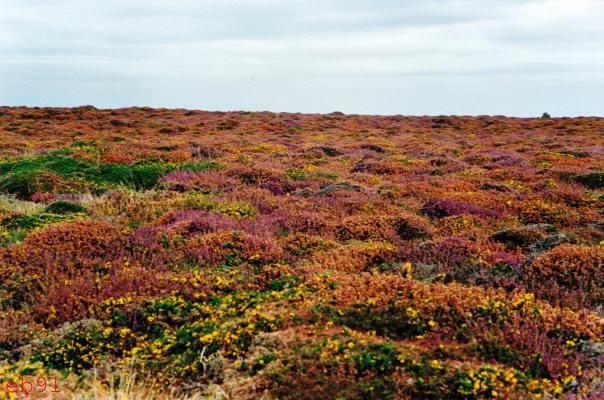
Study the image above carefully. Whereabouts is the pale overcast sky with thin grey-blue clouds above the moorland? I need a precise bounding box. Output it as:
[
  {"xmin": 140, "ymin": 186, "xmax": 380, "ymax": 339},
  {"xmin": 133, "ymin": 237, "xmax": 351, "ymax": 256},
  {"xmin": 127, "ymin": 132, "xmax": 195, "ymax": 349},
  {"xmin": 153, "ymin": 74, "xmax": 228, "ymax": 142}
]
[{"xmin": 0, "ymin": 0, "xmax": 604, "ymax": 116}]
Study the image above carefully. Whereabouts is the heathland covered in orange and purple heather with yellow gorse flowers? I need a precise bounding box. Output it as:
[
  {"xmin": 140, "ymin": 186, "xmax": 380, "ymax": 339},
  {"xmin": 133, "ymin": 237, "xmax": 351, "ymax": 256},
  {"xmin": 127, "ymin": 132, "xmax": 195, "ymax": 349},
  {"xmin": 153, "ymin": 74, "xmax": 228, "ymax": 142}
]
[{"xmin": 0, "ymin": 107, "xmax": 604, "ymax": 399}]
